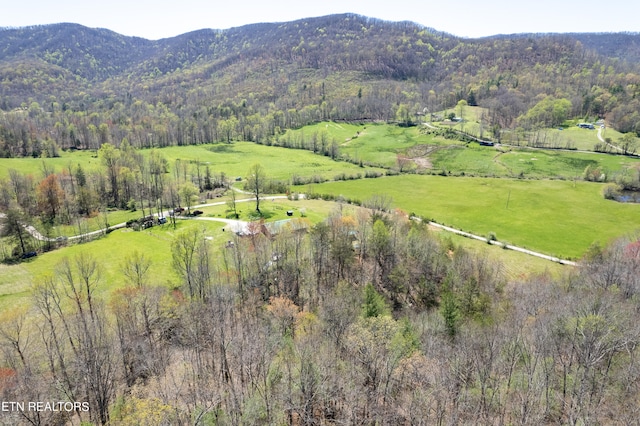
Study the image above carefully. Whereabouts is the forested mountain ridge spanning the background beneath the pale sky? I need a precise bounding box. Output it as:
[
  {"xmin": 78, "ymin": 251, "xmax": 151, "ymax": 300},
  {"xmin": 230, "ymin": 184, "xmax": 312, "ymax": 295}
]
[{"xmin": 0, "ymin": 14, "xmax": 640, "ymax": 156}]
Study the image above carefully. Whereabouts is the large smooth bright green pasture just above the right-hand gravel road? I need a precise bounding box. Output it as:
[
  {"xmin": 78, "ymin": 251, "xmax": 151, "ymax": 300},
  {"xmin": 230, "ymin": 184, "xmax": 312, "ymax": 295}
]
[{"xmin": 301, "ymin": 175, "xmax": 640, "ymax": 259}]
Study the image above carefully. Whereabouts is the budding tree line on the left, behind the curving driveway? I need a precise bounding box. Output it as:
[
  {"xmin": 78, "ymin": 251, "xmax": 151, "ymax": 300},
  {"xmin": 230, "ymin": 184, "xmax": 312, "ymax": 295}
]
[{"xmin": 0, "ymin": 139, "xmax": 232, "ymax": 259}]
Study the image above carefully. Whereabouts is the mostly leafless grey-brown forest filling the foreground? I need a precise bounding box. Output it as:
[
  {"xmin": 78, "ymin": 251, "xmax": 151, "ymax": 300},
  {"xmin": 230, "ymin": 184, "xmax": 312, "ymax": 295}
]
[{"xmin": 0, "ymin": 211, "xmax": 640, "ymax": 425}]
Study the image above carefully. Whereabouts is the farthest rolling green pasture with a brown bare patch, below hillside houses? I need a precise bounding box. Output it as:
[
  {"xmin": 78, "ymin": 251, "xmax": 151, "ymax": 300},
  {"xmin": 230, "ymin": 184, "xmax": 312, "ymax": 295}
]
[{"xmin": 290, "ymin": 123, "xmax": 640, "ymax": 179}]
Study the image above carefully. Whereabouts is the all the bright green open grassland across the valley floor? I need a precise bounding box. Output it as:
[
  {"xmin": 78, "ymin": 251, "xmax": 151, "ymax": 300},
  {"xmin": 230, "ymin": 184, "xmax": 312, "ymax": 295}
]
[{"xmin": 0, "ymin": 120, "xmax": 640, "ymax": 304}]
